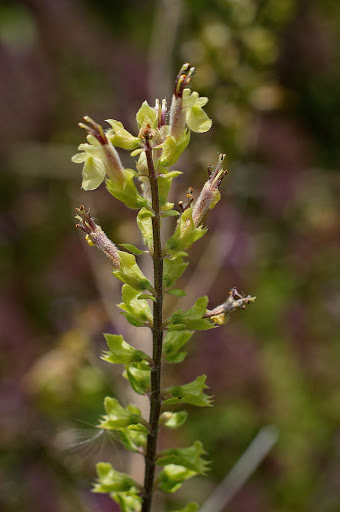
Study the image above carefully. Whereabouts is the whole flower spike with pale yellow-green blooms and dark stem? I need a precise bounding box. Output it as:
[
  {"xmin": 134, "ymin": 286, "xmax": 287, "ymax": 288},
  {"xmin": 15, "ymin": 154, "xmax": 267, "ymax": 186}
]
[{"xmin": 73, "ymin": 64, "xmax": 254, "ymax": 512}]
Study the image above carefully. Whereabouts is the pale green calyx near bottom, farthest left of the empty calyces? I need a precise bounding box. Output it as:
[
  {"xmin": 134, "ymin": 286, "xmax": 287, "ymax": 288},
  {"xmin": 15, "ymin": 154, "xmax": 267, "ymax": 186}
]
[{"xmin": 93, "ymin": 462, "xmax": 139, "ymax": 493}]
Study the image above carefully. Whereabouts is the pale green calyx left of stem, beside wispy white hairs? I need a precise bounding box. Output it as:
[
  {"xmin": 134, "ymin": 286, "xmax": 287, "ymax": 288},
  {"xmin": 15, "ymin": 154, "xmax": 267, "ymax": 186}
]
[{"xmin": 98, "ymin": 396, "xmax": 143, "ymax": 430}]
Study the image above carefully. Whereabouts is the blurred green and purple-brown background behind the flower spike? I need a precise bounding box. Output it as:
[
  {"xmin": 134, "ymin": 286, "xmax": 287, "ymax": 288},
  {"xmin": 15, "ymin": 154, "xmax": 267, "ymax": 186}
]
[{"xmin": 0, "ymin": 0, "xmax": 340, "ymax": 512}]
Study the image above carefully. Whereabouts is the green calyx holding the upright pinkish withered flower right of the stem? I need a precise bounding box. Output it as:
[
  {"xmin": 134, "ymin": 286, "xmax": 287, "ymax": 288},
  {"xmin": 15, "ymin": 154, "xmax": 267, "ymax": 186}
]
[{"xmin": 164, "ymin": 207, "xmax": 207, "ymax": 254}]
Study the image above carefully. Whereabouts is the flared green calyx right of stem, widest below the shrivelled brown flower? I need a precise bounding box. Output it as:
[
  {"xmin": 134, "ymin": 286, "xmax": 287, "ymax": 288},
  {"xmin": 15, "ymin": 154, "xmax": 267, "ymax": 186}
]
[{"xmin": 163, "ymin": 375, "xmax": 212, "ymax": 407}]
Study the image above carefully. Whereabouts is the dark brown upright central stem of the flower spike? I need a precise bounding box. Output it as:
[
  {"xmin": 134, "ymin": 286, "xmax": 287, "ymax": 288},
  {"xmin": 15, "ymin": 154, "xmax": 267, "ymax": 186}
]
[{"xmin": 142, "ymin": 138, "xmax": 163, "ymax": 512}]
